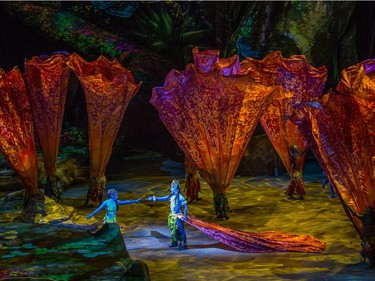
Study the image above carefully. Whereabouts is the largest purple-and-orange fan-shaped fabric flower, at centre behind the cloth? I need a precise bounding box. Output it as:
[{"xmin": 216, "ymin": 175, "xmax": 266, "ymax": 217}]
[{"xmin": 150, "ymin": 49, "xmax": 279, "ymax": 218}]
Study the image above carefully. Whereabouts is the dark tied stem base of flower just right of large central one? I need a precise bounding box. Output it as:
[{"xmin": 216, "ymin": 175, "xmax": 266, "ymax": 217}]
[{"xmin": 285, "ymin": 145, "xmax": 307, "ymax": 200}]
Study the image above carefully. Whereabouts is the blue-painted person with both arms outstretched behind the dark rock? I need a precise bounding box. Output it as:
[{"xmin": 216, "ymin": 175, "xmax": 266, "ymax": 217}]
[{"xmin": 86, "ymin": 189, "xmax": 142, "ymax": 223}]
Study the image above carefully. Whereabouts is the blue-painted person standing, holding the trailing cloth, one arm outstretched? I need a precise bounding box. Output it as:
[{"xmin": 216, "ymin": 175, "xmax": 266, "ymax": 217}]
[{"xmin": 146, "ymin": 180, "xmax": 188, "ymax": 250}]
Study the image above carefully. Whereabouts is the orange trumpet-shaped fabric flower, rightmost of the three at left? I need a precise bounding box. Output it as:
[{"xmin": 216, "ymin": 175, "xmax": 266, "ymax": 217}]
[{"xmin": 67, "ymin": 54, "xmax": 142, "ymax": 205}]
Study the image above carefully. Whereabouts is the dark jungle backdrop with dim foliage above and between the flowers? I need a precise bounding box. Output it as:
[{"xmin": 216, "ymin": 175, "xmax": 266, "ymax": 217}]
[{"xmin": 0, "ymin": 1, "xmax": 375, "ymax": 173}]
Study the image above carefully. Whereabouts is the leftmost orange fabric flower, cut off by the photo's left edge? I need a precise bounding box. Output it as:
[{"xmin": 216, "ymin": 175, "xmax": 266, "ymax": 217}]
[{"xmin": 0, "ymin": 67, "xmax": 39, "ymax": 197}]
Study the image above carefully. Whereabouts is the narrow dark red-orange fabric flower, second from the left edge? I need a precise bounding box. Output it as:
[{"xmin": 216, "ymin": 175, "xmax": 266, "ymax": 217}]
[{"xmin": 24, "ymin": 53, "xmax": 70, "ymax": 200}]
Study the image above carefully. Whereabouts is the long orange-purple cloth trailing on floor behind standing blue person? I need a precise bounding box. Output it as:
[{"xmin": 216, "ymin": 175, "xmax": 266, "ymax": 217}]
[{"xmin": 185, "ymin": 217, "xmax": 326, "ymax": 253}]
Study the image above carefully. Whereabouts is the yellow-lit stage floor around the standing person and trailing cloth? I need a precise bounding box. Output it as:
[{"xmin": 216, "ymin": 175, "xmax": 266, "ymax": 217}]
[{"xmin": 0, "ymin": 156, "xmax": 375, "ymax": 281}]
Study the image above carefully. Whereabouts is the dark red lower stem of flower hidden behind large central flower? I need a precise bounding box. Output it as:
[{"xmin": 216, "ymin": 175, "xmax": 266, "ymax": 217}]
[{"xmin": 184, "ymin": 156, "xmax": 201, "ymax": 203}]
